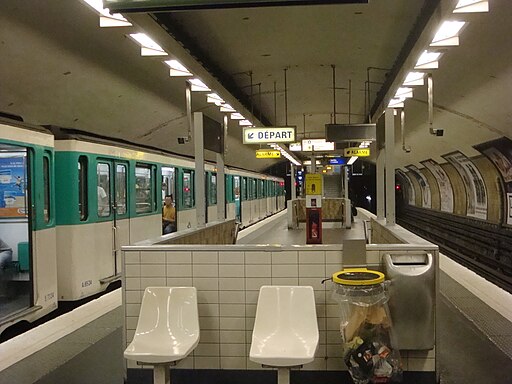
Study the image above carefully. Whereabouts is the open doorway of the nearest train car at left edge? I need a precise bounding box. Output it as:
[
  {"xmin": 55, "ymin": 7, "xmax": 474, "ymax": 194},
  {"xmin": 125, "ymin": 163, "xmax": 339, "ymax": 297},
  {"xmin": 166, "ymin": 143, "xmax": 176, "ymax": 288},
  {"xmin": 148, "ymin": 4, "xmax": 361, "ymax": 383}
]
[{"xmin": 0, "ymin": 146, "xmax": 32, "ymax": 320}]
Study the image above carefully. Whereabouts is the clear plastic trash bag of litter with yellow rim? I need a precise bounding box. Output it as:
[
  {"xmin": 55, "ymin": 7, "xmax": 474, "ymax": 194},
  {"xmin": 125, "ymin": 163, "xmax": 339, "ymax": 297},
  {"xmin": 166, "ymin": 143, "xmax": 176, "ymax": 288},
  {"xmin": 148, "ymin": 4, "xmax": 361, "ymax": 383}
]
[{"xmin": 332, "ymin": 268, "xmax": 402, "ymax": 384}]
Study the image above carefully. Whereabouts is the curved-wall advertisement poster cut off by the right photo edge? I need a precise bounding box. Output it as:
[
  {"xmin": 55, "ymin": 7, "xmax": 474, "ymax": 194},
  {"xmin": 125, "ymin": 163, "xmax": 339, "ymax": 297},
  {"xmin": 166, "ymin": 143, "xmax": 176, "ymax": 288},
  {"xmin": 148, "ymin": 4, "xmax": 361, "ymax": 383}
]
[{"xmin": 474, "ymin": 137, "xmax": 512, "ymax": 225}]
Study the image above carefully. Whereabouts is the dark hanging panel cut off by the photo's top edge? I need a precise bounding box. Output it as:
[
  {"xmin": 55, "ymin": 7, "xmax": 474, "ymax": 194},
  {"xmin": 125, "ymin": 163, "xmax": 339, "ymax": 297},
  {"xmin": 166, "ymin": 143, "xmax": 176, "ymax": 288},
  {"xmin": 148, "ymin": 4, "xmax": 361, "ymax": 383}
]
[{"xmin": 103, "ymin": 0, "xmax": 368, "ymax": 13}]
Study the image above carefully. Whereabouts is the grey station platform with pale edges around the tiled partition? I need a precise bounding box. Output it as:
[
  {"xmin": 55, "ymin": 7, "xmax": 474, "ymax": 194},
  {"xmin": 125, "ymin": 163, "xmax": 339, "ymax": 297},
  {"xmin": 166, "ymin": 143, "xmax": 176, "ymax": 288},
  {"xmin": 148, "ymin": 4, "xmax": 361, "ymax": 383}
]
[{"xmin": 0, "ymin": 213, "xmax": 512, "ymax": 384}]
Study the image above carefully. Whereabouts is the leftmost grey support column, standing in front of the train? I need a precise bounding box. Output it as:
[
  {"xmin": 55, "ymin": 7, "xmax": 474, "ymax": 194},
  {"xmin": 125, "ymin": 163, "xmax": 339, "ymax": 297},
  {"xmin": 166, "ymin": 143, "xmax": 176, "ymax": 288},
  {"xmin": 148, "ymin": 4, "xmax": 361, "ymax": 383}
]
[{"xmin": 194, "ymin": 112, "xmax": 206, "ymax": 228}]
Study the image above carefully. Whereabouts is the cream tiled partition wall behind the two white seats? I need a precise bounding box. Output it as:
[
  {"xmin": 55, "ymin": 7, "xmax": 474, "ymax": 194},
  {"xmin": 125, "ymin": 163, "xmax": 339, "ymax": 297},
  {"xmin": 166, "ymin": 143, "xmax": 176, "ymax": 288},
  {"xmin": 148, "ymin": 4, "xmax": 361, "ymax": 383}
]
[{"xmin": 123, "ymin": 244, "xmax": 438, "ymax": 372}]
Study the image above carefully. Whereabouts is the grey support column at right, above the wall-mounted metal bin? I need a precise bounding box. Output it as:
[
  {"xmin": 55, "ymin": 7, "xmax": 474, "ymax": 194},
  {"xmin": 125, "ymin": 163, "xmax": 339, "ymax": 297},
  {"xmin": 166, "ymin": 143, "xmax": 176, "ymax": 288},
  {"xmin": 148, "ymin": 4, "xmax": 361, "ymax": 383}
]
[{"xmin": 385, "ymin": 108, "xmax": 396, "ymax": 225}]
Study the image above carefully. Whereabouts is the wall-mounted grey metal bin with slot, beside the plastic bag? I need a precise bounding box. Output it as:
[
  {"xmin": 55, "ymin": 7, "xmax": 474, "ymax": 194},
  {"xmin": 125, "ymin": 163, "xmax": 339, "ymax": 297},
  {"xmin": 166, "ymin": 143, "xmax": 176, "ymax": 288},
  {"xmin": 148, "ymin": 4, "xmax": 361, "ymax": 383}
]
[{"xmin": 384, "ymin": 253, "xmax": 436, "ymax": 350}]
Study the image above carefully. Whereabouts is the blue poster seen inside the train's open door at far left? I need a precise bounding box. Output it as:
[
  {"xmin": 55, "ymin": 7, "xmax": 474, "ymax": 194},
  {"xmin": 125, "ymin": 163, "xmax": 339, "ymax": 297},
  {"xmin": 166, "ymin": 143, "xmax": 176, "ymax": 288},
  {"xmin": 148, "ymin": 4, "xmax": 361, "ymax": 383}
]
[{"xmin": 0, "ymin": 154, "xmax": 27, "ymax": 218}]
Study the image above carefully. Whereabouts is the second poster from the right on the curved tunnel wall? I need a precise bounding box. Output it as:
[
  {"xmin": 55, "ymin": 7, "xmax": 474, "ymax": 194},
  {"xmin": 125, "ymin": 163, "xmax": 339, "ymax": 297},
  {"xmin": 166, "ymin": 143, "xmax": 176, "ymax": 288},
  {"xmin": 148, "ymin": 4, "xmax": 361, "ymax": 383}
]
[{"xmin": 443, "ymin": 152, "xmax": 487, "ymax": 220}]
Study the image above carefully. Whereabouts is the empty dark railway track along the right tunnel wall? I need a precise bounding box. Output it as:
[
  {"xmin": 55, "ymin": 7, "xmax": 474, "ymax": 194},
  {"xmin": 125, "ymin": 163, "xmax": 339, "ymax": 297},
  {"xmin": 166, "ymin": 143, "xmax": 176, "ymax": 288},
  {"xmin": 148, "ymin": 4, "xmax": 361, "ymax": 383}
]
[{"xmin": 397, "ymin": 207, "xmax": 512, "ymax": 293}]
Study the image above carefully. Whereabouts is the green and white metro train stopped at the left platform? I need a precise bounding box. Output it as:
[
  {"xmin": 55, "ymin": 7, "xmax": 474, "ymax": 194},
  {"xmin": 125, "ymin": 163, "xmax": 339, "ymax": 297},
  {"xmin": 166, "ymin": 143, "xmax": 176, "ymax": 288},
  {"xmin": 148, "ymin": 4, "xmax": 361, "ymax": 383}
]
[{"xmin": 0, "ymin": 118, "xmax": 285, "ymax": 333}]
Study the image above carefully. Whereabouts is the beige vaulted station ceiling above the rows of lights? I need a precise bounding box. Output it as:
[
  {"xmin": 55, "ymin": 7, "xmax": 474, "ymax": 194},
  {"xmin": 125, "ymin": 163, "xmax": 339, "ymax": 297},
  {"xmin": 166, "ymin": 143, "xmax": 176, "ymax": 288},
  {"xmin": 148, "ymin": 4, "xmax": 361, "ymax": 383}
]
[{"xmin": 0, "ymin": 0, "xmax": 512, "ymax": 171}]
